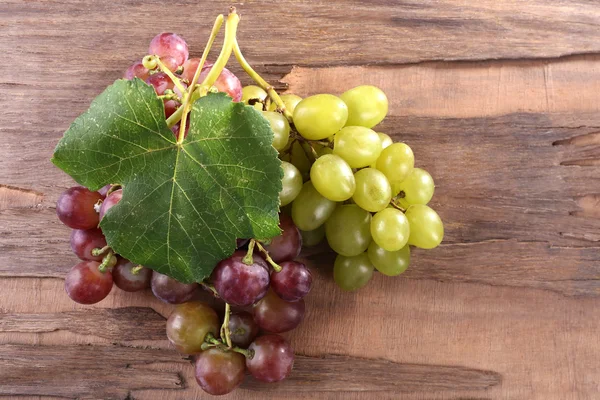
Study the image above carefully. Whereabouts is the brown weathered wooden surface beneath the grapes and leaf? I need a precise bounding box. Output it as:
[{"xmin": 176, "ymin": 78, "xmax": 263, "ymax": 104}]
[{"xmin": 0, "ymin": 0, "xmax": 600, "ymax": 400}]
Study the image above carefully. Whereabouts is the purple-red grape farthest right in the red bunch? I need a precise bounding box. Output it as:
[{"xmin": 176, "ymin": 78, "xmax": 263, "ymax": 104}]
[{"xmin": 271, "ymin": 261, "xmax": 312, "ymax": 301}]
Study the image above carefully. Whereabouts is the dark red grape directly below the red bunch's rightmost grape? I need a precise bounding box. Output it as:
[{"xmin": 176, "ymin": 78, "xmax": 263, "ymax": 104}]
[{"xmin": 252, "ymin": 290, "xmax": 305, "ymax": 333}]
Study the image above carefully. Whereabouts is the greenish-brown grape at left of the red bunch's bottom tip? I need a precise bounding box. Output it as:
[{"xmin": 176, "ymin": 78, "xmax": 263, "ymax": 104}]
[{"xmin": 167, "ymin": 301, "xmax": 219, "ymax": 354}]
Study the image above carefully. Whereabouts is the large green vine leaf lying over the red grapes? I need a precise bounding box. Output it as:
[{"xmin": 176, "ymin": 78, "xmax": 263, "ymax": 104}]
[{"xmin": 52, "ymin": 79, "xmax": 282, "ymax": 282}]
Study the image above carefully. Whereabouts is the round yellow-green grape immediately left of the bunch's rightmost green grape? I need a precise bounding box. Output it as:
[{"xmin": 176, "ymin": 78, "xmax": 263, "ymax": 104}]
[{"xmin": 371, "ymin": 208, "xmax": 410, "ymax": 251}]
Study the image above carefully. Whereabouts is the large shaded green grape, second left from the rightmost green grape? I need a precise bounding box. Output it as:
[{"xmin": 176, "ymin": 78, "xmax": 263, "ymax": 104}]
[{"xmin": 325, "ymin": 204, "xmax": 371, "ymax": 257}]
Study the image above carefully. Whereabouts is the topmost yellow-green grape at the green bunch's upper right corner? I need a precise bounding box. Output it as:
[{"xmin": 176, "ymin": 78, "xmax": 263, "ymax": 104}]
[{"xmin": 340, "ymin": 85, "xmax": 388, "ymax": 128}]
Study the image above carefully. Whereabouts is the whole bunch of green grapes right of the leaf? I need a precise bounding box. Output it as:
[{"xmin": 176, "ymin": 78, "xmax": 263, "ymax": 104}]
[{"xmin": 242, "ymin": 85, "xmax": 444, "ymax": 290}]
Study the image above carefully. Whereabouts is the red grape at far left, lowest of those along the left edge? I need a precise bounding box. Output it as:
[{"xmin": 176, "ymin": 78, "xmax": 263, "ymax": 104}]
[{"xmin": 65, "ymin": 261, "xmax": 113, "ymax": 304}]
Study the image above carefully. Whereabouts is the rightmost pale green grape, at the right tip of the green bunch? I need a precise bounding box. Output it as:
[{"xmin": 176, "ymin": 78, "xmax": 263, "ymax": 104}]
[{"xmin": 406, "ymin": 204, "xmax": 444, "ymax": 249}]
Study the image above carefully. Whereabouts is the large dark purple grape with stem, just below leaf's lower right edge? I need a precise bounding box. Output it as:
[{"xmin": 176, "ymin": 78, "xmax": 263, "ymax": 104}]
[{"xmin": 211, "ymin": 250, "xmax": 269, "ymax": 307}]
